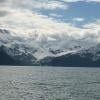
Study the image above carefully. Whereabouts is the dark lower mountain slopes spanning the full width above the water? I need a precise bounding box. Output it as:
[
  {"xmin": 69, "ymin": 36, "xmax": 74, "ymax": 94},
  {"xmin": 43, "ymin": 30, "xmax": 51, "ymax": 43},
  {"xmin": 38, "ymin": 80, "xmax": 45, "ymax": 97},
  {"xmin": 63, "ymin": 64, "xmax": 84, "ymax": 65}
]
[{"xmin": 0, "ymin": 45, "xmax": 100, "ymax": 67}]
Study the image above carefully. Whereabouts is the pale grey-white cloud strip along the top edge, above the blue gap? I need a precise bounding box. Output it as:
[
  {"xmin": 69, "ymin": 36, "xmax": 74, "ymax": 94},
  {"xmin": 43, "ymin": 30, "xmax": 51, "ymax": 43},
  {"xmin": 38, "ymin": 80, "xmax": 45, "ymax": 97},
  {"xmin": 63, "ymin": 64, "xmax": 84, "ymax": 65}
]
[{"xmin": 5, "ymin": 0, "xmax": 68, "ymax": 10}]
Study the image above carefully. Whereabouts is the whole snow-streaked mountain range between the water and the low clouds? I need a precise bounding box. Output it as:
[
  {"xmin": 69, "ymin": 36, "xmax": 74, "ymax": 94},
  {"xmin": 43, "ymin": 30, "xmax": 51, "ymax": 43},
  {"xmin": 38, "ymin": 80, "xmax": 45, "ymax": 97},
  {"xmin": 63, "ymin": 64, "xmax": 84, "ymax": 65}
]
[{"xmin": 0, "ymin": 29, "xmax": 100, "ymax": 67}]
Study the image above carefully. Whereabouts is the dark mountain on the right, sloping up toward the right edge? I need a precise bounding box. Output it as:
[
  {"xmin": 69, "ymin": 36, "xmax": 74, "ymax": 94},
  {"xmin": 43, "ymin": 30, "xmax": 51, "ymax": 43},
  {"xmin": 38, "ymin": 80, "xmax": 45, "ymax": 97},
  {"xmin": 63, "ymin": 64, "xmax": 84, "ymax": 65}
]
[{"xmin": 41, "ymin": 44, "xmax": 100, "ymax": 67}]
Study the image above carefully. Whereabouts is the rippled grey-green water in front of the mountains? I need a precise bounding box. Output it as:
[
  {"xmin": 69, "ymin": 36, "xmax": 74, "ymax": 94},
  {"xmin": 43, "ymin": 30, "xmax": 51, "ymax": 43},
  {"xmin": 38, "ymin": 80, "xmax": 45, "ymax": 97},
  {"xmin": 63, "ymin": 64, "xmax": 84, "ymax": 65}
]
[{"xmin": 0, "ymin": 66, "xmax": 100, "ymax": 100}]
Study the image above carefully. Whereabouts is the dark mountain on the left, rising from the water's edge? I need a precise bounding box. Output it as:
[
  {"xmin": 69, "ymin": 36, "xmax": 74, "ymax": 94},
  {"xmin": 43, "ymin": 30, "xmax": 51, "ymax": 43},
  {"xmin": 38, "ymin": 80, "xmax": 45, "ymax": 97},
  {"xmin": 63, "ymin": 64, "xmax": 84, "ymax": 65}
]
[{"xmin": 0, "ymin": 46, "xmax": 37, "ymax": 66}]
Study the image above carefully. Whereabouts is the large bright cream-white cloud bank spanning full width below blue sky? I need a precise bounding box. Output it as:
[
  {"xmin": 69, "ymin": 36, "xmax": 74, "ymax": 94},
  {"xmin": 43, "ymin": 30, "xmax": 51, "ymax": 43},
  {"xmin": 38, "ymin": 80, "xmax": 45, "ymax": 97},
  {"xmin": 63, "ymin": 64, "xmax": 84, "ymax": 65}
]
[{"xmin": 0, "ymin": 6, "xmax": 100, "ymax": 43}]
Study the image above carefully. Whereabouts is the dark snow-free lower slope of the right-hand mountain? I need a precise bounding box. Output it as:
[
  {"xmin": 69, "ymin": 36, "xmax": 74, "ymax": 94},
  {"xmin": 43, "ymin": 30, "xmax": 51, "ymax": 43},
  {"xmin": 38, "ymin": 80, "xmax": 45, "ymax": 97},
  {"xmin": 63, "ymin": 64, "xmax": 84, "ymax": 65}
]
[{"xmin": 46, "ymin": 54, "xmax": 100, "ymax": 67}]
